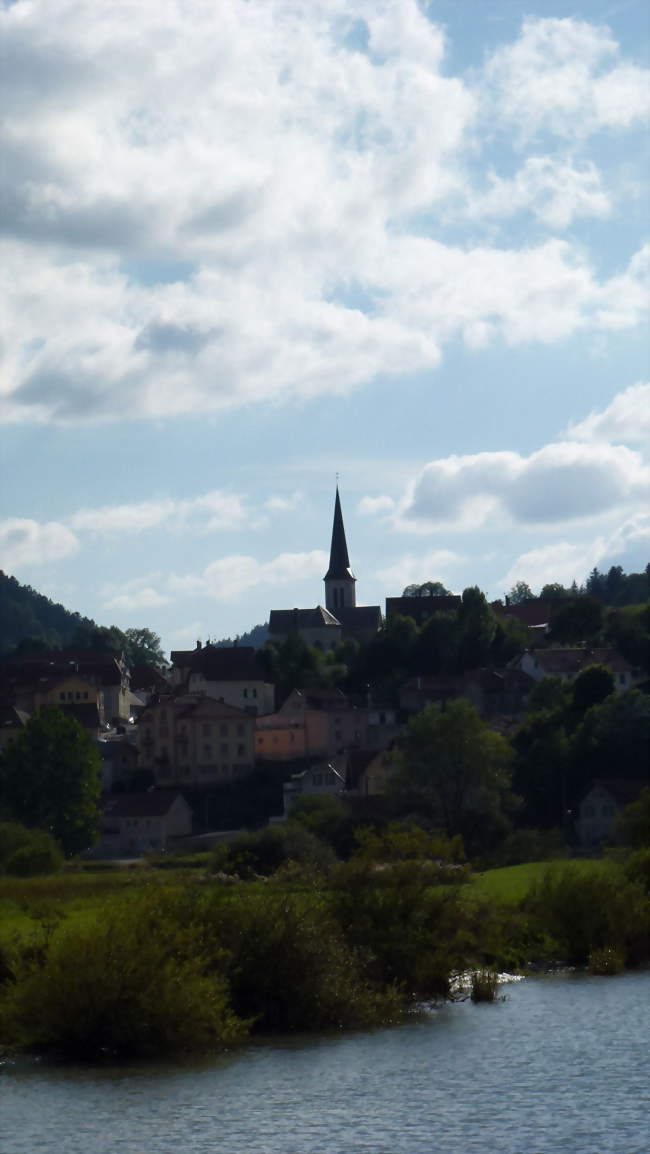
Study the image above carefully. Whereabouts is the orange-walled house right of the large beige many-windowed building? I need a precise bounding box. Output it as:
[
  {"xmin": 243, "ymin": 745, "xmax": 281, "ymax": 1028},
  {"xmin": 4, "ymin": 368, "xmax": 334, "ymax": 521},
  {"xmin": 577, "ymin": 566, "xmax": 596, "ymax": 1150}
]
[{"xmin": 255, "ymin": 689, "xmax": 367, "ymax": 760}]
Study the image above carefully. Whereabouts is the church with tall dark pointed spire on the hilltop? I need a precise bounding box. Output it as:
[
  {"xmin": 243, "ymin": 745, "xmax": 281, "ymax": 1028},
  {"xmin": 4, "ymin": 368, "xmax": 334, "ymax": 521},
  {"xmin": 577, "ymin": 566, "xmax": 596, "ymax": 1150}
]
[{"xmin": 269, "ymin": 485, "xmax": 381, "ymax": 651}]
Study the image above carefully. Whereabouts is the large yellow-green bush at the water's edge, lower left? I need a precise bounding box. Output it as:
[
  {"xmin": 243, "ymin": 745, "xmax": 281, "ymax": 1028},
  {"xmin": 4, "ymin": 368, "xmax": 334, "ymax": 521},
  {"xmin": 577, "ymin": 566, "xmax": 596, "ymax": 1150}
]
[{"xmin": 0, "ymin": 899, "xmax": 245, "ymax": 1057}]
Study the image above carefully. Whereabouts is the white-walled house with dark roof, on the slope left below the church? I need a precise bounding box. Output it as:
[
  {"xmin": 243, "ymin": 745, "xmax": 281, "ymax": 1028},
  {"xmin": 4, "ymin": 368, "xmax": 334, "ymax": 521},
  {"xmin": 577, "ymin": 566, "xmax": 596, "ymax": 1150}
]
[{"xmin": 170, "ymin": 642, "xmax": 275, "ymax": 715}]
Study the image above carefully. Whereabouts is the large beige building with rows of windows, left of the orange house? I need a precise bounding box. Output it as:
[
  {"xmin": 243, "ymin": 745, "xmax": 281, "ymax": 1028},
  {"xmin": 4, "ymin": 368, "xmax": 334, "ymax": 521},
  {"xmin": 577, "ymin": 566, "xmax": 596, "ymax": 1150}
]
[{"xmin": 137, "ymin": 694, "xmax": 255, "ymax": 787}]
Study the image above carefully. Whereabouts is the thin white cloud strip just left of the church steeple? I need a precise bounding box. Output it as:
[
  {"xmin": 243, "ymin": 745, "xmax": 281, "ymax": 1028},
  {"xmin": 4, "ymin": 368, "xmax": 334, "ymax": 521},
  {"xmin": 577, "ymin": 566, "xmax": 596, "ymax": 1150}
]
[{"xmin": 167, "ymin": 549, "xmax": 328, "ymax": 601}]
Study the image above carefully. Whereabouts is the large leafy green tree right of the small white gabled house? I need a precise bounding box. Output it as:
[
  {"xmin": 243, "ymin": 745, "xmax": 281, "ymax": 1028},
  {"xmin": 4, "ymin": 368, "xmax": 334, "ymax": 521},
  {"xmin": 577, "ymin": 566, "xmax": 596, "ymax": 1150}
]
[{"xmin": 397, "ymin": 699, "xmax": 513, "ymax": 853}]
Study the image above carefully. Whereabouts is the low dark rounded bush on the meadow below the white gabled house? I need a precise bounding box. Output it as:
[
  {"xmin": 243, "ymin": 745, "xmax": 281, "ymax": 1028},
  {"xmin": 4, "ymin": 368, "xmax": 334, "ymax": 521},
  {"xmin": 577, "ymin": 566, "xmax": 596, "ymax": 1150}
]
[{"xmin": 211, "ymin": 822, "xmax": 335, "ymax": 878}]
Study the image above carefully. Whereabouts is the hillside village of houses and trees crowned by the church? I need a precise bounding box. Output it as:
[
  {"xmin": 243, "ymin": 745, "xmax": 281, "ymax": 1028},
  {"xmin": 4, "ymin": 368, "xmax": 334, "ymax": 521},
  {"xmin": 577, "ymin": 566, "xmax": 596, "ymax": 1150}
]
[{"xmin": 0, "ymin": 489, "xmax": 649, "ymax": 857}]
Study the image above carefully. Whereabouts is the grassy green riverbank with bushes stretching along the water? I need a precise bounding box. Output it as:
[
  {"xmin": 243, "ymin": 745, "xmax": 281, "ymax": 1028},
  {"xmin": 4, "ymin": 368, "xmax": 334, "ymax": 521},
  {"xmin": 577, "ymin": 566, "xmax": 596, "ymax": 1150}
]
[{"xmin": 0, "ymin": 860, "xmax": 650, "ymax": 1058}]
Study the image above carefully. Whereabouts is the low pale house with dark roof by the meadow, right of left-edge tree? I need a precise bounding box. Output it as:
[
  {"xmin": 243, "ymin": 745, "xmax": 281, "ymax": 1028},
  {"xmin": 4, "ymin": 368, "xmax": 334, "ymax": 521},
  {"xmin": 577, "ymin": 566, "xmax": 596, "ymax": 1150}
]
[{"xmin": 94, "ymin": 789, "xmax": 192, "ymax": 857}]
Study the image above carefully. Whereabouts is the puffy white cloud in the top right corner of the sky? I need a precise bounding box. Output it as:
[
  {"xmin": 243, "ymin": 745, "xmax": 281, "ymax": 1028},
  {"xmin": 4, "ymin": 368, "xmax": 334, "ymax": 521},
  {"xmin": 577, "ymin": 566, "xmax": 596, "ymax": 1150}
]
[{"xmin": 486, "ymin": 17, "xmax": 650, "ymax": 140}]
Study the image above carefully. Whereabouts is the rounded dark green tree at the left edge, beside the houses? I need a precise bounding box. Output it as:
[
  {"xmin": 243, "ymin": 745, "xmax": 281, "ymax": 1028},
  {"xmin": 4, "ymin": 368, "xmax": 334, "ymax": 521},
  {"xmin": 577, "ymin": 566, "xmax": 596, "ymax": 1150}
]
[{"xmin": 0, "ymin": 706, "xmax": 102, "ymax": 855}]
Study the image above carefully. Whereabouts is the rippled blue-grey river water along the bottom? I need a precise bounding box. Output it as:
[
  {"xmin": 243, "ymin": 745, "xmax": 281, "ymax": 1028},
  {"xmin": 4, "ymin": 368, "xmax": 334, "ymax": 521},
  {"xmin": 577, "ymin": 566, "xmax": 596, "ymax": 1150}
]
[{"xmin": 0, "ymin": 973, "xmax": 650, "ymax": 1154}]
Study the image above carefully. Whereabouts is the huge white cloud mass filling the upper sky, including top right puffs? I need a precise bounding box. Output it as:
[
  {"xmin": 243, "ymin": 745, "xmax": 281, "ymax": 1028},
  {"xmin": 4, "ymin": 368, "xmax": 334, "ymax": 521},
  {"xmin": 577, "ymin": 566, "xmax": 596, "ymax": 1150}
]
[{"xmin": 0, "ymin": 0, "xmax": 645, "ymax": 424}]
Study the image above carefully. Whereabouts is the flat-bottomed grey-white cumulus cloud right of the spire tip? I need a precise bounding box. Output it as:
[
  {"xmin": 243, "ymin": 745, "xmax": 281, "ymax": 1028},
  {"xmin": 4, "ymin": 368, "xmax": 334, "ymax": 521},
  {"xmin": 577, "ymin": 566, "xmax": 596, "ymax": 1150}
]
[{"xmin": 398, "ymin": 441, "xmax": 650, "ymax": 530}]
